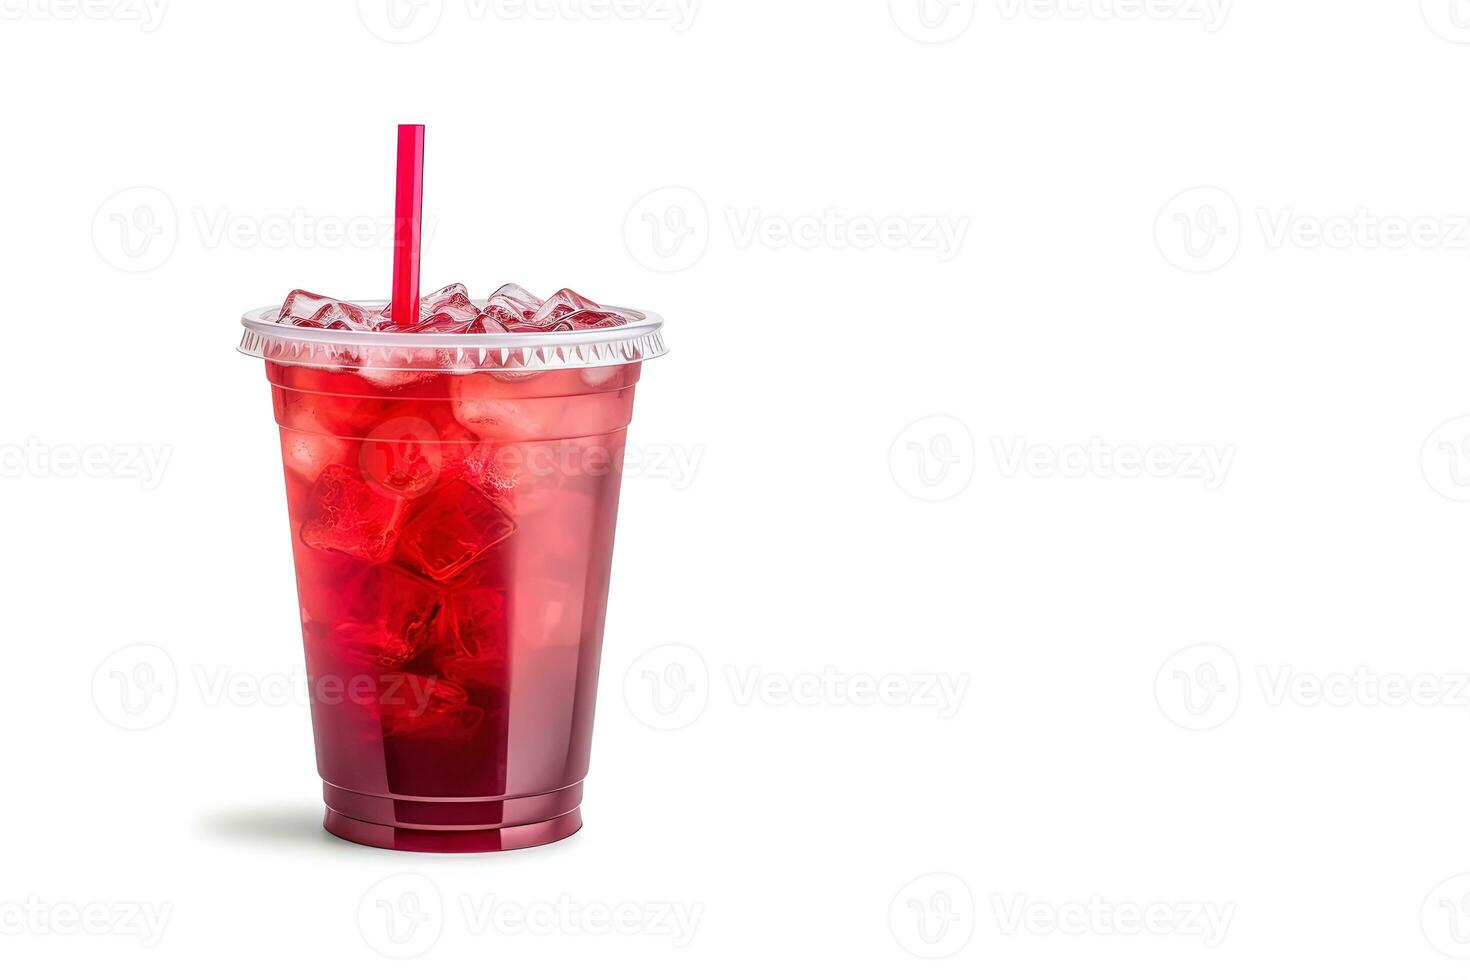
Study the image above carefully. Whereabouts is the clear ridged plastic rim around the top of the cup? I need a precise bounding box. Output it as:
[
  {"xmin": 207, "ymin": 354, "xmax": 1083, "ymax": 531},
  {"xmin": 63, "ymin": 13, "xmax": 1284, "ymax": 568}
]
[{"xmin": 238, "ymin": 301, "xmax": 667, "ymax": 373}]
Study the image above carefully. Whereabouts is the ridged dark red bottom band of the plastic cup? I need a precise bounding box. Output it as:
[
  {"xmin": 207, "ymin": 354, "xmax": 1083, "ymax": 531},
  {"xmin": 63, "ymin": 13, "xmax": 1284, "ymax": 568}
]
[{"xmin": 322, "ymin": 782, "xmax": 582, "ymax": 854}]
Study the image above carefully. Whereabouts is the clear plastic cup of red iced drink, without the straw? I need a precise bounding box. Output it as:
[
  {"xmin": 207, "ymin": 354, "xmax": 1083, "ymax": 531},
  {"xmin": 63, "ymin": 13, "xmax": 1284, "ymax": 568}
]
[{"xmin": 240, "ymin": 304, "xmax": 664, "ymax": 852}]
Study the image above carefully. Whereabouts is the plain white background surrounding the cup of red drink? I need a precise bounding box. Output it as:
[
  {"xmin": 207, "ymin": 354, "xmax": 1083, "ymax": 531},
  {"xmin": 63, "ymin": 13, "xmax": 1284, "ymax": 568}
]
[{"xmin": 0, "ymin": 0, "xmax": 1470, "ymax": 977}]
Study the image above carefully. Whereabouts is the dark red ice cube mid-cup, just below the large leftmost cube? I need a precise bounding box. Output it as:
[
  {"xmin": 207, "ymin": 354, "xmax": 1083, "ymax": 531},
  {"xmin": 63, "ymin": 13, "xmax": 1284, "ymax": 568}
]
[{"xmin": 334, "ymin": 564, "xmax": 444, "ymax": 670}]
